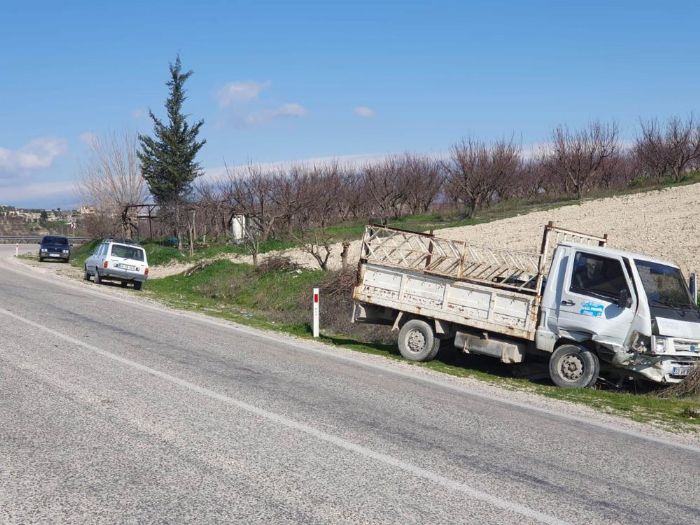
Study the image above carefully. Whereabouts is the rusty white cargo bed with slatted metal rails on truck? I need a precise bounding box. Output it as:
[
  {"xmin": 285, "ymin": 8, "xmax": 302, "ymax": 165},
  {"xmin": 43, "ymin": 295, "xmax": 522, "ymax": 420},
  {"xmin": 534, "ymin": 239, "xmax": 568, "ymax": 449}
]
[{"xmin": 353, "ymin": 223, "xmax": 607, "ymax": 341}]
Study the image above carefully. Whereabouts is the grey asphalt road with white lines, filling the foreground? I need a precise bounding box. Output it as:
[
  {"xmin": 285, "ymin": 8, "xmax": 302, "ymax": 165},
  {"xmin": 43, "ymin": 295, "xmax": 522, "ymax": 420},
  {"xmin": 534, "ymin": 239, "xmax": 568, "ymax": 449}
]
[{"xmin": 0, "ymin": 250, "xmax": 700, "ymax": 524}]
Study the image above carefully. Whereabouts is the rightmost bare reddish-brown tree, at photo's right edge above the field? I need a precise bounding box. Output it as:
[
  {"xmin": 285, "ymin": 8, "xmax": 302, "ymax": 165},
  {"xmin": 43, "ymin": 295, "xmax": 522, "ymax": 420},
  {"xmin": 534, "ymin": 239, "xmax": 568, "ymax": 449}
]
[{"xmin": 635, "ymin": 115, "xmax": 700, "ymax": 182}]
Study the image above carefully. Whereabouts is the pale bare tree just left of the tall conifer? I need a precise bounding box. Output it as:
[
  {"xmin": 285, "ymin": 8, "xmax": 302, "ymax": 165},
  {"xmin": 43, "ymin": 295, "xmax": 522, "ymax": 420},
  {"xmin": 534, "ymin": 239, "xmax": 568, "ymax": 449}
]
[{"xmin": 77, "ymin": 133, "xmax": 149, "ymax": 233}]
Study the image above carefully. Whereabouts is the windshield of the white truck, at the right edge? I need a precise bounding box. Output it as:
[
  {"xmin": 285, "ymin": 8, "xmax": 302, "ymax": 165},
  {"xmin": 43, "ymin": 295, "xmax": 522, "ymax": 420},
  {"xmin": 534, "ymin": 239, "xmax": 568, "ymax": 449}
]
[{"xmin": 634, "ymin": 259, "xmax": 695, "ymax": 308}]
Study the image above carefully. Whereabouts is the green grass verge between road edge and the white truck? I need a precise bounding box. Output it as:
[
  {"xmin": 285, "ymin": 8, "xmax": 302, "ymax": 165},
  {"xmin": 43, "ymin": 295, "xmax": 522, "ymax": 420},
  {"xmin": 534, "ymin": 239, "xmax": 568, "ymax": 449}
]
[{"xmin": 147, "ymin": 261, "xmax": 700, "ymax": 432}]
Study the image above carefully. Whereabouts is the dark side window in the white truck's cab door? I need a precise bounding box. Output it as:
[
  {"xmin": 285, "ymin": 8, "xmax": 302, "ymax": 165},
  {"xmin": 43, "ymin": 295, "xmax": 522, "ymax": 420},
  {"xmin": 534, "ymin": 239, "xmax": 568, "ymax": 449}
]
[{"xmin": 569, "ymin": 252, "xmax": 629, "ymax": 301}]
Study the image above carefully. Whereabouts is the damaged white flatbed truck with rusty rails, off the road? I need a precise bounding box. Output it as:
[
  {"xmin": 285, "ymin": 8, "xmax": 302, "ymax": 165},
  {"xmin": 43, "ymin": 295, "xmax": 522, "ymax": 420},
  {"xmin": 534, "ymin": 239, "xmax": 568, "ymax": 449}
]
[{"xmin": 353, "ymin": 222, "xmax": 700, "ymax": 387}]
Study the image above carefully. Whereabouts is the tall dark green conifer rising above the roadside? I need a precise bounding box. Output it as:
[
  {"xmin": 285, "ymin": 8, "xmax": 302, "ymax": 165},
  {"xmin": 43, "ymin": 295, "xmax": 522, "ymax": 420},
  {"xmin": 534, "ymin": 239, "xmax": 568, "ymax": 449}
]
[{"xmin": 138, "ymin": 55, "xmax": 206, "ymax": 249}]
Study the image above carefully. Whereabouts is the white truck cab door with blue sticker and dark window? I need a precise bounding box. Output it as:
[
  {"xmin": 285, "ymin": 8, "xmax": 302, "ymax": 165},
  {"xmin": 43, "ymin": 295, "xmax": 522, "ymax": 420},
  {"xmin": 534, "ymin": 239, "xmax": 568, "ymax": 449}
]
[{"xmin": 557, "ymin": 250, "xmax": 637, "ymax": 345}]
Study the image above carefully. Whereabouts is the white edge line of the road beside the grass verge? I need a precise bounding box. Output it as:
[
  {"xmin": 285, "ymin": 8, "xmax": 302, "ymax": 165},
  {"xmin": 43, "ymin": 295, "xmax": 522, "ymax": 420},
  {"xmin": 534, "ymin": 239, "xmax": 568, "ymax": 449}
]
[{"xmin": 0, "ymin": 259, "xmax": 700, "ymax": 454}]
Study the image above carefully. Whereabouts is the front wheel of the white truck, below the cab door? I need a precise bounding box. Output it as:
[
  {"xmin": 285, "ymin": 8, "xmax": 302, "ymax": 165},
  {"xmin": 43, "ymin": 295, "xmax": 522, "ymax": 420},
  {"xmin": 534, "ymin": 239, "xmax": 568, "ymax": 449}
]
[{"xmin": 549, "ymin": 344, "xmax": 600, "ymax": 388}]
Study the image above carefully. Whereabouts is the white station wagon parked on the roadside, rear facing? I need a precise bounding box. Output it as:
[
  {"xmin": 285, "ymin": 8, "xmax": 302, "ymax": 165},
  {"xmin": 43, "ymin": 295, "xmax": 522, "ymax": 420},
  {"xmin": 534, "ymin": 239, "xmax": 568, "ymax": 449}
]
[{"xmin": 83, "ymin": 239, "xmax": 148, "ymax": 290}]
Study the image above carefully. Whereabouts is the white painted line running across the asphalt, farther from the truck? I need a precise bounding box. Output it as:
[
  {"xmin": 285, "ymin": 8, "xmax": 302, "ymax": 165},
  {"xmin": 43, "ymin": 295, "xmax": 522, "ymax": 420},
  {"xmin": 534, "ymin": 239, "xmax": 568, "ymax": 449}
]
[{"xmin": 0, "ymin": 308, "xmax": 567, "ymax": 524}]
